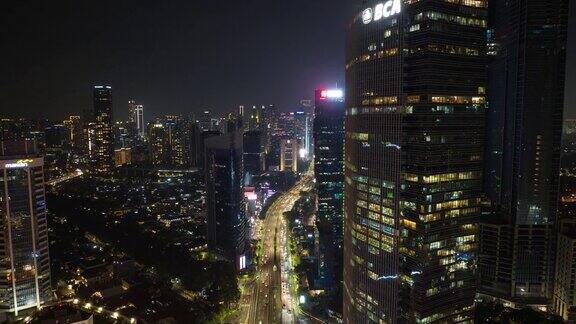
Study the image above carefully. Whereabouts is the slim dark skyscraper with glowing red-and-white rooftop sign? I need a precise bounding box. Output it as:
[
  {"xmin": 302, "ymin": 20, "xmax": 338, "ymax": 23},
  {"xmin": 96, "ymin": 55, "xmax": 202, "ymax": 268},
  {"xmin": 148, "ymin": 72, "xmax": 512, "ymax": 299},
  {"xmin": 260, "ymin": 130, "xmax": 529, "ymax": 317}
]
[{"xmin": 313, "ymin": 90, "xmax": 344, "ymax": 287}]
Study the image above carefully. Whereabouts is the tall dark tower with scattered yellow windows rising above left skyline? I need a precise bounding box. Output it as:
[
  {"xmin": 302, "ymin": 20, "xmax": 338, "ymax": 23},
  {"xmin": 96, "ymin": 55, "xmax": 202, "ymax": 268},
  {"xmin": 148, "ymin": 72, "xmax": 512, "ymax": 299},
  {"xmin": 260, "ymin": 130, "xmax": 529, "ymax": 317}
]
[{"xmin": 87, "ymin": 86, "xmax": 114, "ymax": 174}]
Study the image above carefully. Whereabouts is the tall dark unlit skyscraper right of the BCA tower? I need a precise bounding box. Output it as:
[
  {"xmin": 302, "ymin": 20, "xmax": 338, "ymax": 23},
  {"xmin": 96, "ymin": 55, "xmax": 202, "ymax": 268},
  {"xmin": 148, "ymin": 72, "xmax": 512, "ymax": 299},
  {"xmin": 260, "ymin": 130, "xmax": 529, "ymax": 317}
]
[{"xmin": 478, "ymin": 0, "xmax": 568, "ymax": 310}]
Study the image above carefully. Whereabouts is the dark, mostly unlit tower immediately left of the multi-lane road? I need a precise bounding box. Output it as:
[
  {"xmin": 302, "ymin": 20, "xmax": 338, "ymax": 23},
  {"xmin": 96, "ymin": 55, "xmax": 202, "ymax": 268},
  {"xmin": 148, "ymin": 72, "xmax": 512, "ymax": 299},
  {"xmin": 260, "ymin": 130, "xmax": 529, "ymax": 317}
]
[{"xmin": 205, "ymin": 131, "xmax": 250, "ymax": 270}]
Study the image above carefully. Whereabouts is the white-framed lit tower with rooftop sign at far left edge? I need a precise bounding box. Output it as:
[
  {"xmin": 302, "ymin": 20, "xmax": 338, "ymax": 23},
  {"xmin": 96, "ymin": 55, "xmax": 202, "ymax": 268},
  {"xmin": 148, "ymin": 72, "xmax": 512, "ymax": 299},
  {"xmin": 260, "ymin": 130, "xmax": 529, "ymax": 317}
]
[{"xmin": 0, "ymin": 141, "xmax": 52, "ymax": 318}]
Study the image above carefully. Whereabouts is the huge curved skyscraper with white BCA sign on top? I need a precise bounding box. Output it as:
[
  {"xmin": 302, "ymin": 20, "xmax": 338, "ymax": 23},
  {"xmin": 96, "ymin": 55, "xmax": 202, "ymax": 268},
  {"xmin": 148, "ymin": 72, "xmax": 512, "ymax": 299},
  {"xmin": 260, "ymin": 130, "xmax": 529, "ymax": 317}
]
[{"xmin": 344, "ymin": 0, "xmax": 488, "ymax": 323}]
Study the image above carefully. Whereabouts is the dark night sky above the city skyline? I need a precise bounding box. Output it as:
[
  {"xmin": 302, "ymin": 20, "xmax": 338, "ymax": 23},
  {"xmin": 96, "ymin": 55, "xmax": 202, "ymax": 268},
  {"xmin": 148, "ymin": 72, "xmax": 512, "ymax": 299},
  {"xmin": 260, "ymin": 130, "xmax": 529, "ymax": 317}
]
[{"xmin": 0, "ymin": 0, "xmax": 576, "ymax": 120}]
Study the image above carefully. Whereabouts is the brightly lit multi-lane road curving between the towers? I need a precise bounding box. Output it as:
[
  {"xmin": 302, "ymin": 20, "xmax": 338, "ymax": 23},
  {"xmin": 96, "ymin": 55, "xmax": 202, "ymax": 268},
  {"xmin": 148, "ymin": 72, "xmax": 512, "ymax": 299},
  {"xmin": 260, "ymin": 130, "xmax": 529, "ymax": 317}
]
[{"xmin": 234, "ymin": 173, "xmax": 313, "ymax": 324}]
